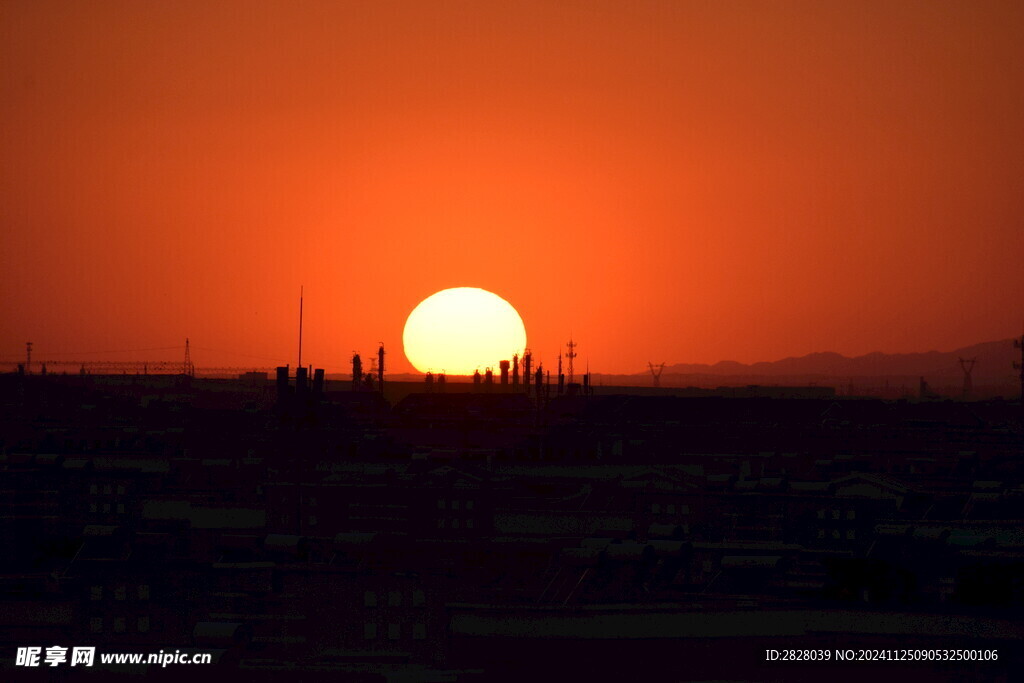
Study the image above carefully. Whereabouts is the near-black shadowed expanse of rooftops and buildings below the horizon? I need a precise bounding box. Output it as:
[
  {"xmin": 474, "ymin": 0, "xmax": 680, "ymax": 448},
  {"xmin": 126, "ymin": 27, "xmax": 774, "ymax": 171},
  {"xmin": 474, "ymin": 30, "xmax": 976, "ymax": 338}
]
[{"xmin": 0, "ymin": 375, "xmax": 1024, "ymax": 681}]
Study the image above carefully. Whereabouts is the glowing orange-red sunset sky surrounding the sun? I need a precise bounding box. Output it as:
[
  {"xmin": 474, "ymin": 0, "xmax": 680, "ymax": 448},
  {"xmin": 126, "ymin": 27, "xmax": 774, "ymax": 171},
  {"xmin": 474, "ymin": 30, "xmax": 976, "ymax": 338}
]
[{"xmin": 0, "ymin": 0, "xmax": 1024, "ymax": 373}]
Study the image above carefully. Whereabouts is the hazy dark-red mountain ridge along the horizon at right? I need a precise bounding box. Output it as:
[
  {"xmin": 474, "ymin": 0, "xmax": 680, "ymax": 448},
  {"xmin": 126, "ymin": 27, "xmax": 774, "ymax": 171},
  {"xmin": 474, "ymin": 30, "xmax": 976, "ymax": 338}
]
[{"xmin": 638, "ymin": 339, "xmax": 1020, "ymax": 384}]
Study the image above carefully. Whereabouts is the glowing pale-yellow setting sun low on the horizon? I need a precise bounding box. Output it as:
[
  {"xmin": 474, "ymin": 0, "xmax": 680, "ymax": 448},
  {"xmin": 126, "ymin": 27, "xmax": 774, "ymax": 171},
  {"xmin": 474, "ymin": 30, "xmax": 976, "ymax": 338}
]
[{"xmin": 402, "ymin": 287, "xmax": 526, "ymax": 375}]
